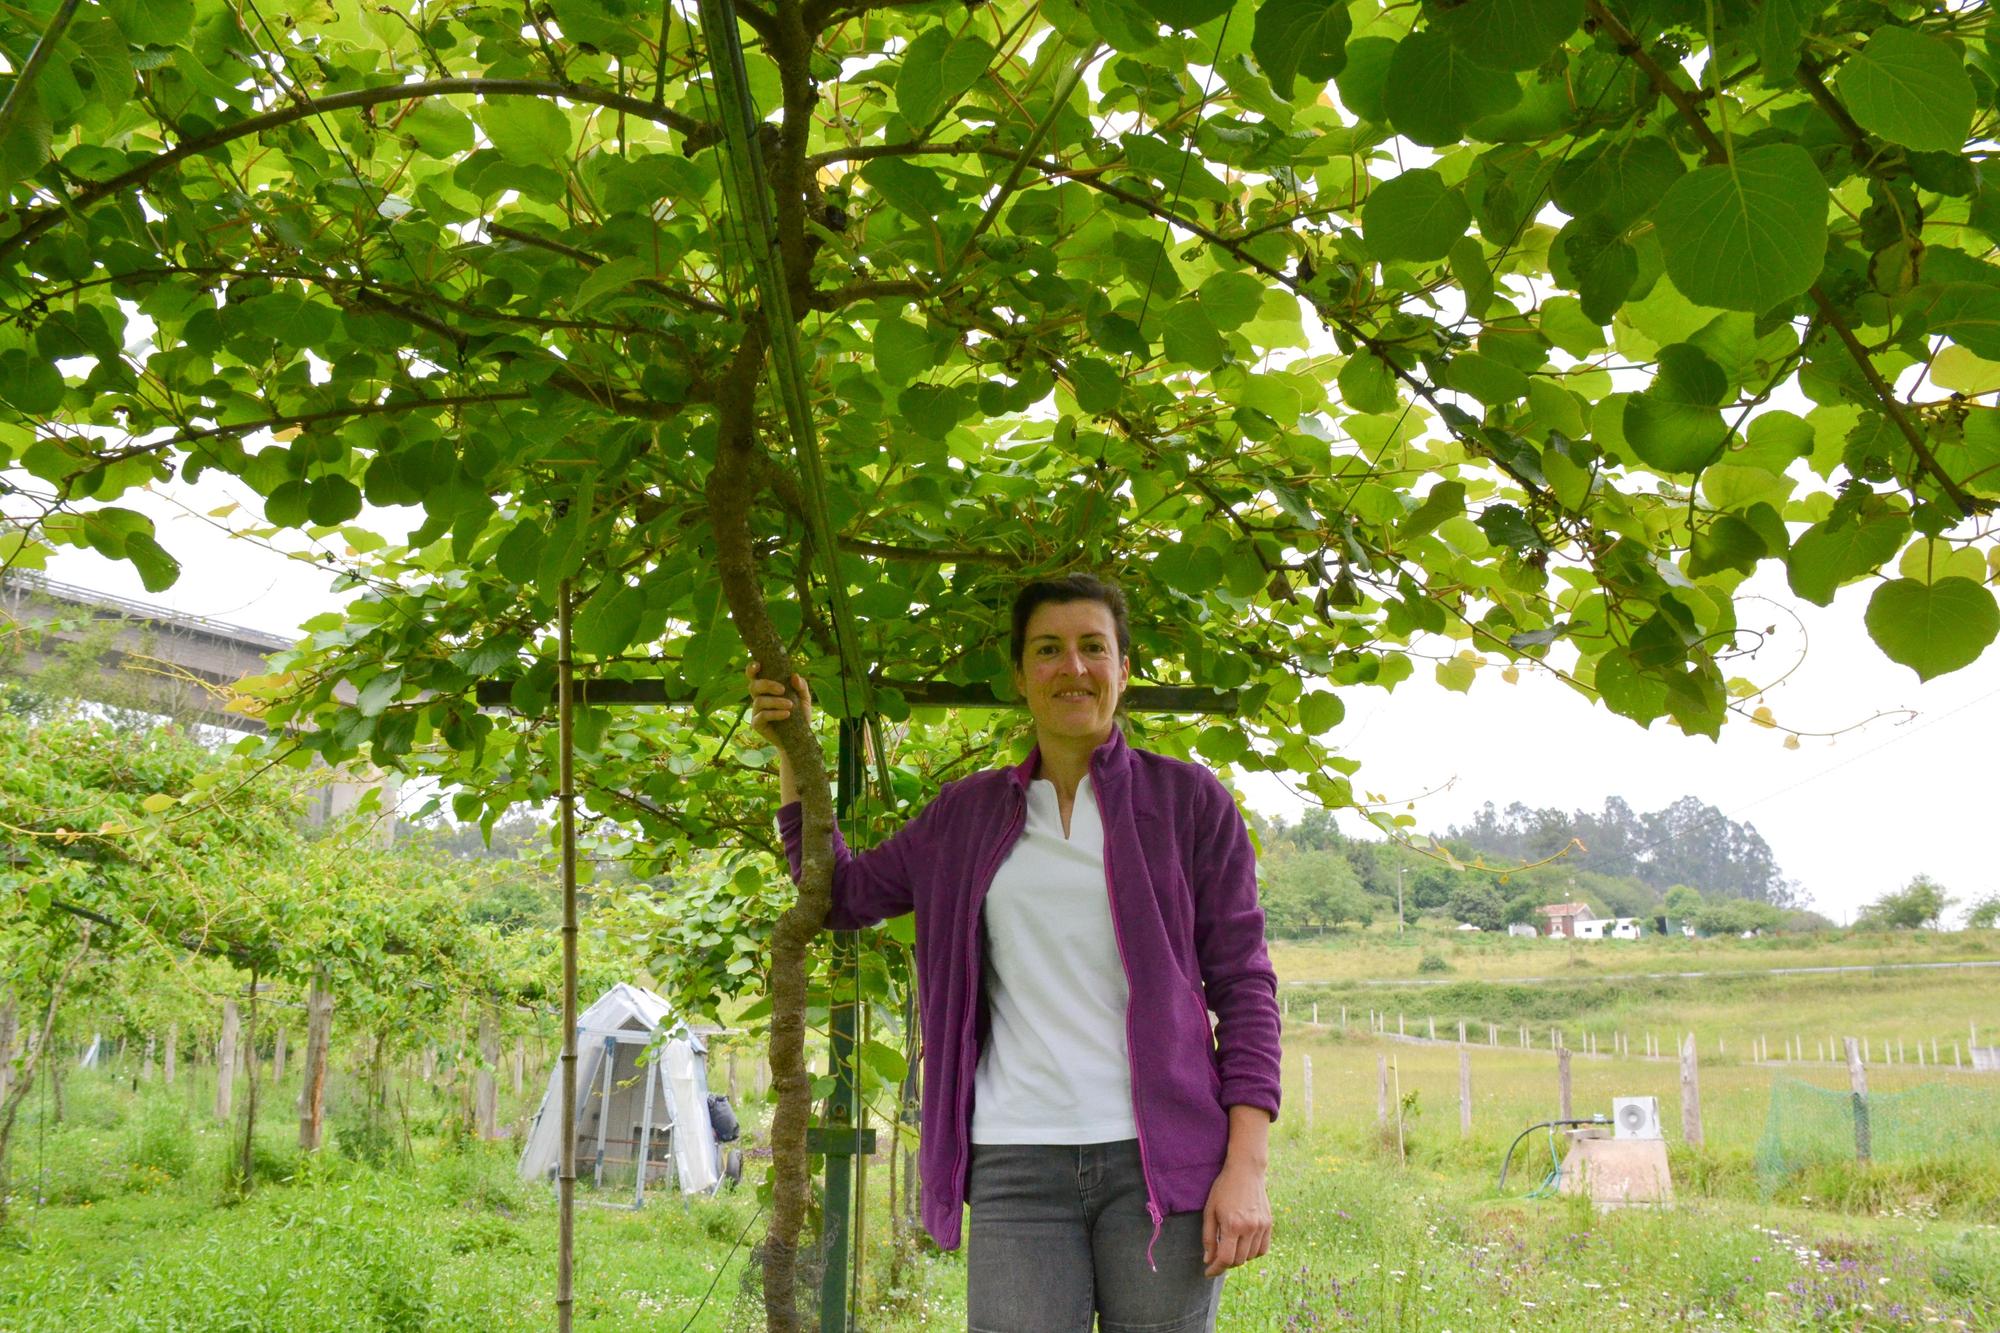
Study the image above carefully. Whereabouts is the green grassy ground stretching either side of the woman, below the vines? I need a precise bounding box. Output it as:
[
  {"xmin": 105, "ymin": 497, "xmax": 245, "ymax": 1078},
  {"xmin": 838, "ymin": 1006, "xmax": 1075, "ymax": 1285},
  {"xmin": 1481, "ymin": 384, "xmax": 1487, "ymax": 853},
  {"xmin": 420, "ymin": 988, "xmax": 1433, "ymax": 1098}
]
[{"xmin": 0, "ymin": 928, "xmax": 2000, "ymax": 1333}]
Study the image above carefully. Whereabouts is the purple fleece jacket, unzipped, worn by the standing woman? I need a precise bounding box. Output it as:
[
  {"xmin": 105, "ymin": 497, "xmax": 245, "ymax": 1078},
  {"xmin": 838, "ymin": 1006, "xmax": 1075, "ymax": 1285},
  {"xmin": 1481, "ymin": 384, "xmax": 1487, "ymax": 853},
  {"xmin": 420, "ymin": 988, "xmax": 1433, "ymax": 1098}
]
[{"xmin": 778, "ymin": 727, "xmax": 1280, "ymax": 1249}]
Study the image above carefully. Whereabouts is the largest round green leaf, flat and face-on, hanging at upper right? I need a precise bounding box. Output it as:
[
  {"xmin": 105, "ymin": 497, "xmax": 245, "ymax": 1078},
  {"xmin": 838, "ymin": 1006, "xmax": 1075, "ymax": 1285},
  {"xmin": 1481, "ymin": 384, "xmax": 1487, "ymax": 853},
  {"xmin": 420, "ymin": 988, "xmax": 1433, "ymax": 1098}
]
[{"xmin": 1654, "ymin": 144, "xmax": 1826, "ymax": 314}]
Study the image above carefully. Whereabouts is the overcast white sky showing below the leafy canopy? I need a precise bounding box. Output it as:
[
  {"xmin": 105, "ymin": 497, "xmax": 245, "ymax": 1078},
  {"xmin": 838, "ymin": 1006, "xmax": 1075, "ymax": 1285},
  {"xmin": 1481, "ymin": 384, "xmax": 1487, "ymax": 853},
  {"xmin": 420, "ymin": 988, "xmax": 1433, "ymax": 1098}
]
[{"xmin": 35, "ymin": 472, "xmax": 2000, "ymax": 921}]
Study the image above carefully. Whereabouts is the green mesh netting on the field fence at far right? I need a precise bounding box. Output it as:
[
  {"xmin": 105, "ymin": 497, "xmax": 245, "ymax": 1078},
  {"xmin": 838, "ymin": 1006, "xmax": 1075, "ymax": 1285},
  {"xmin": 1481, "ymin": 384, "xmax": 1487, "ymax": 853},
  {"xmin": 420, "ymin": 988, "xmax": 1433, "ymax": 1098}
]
[{"xmin": 1756, "ymin": 1079, "xmax": 2000, "ymax": 1195}]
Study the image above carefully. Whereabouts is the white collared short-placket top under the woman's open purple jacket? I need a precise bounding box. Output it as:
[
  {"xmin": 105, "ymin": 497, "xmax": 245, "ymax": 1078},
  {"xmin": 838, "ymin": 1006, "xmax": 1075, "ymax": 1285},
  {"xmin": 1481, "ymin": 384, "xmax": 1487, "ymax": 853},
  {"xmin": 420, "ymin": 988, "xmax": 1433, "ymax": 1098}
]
[{"xmin": 972, "ymin": 777, "xmax": 1138, "ymax": 1143}]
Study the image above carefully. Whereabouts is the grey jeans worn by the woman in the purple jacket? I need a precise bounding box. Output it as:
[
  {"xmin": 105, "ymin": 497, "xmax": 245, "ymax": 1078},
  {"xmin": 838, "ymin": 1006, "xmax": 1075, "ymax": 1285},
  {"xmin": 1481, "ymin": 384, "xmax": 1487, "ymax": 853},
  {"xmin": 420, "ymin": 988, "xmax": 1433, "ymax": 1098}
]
[{"xmin": 966, "ymin": 1139, "xmax": 1222, "ymax": 1333}]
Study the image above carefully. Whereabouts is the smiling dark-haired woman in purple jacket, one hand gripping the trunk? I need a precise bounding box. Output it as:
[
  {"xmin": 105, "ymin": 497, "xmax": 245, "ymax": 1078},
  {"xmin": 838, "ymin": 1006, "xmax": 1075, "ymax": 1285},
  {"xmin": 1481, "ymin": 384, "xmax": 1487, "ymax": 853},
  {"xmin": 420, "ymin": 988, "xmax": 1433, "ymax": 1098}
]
[{"xmin": 750, "ymin": 574, "xmax": 1278, "ymax": 1333}]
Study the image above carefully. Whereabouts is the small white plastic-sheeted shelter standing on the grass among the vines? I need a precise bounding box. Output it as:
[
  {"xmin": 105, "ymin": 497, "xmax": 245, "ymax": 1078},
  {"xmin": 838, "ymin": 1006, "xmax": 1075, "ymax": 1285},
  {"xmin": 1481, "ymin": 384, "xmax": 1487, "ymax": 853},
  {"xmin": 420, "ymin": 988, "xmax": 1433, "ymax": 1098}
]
[{"xmin": 520, "ymin": 981, "xmax": 722, "ymax": 1203}]
